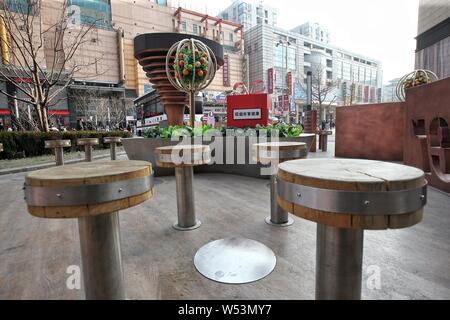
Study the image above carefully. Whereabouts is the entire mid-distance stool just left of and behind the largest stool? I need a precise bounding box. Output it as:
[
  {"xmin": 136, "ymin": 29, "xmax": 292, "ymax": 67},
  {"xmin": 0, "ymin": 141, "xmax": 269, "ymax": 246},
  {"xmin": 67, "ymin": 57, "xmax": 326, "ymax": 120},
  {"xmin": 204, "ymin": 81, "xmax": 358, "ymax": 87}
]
[{"xmin": 253, "ymin": 142, "xmax": 306, "ymax": 227}]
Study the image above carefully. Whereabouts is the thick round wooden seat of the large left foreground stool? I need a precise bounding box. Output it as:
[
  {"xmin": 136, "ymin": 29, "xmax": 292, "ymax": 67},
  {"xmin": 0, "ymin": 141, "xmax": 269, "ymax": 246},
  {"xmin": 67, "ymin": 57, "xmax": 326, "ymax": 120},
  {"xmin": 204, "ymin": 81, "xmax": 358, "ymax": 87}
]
[{"xmin": 25, "ymin": 160, "xmax": 153, "ymax": 218}]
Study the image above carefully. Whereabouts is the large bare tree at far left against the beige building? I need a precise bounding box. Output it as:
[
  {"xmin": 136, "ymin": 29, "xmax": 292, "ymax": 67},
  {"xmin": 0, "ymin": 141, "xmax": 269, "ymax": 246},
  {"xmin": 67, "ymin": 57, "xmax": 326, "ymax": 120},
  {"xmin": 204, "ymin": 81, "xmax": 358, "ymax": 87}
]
[{"xmin": 0, "ymin": 0, "xmax": 98, "ymax": 131}]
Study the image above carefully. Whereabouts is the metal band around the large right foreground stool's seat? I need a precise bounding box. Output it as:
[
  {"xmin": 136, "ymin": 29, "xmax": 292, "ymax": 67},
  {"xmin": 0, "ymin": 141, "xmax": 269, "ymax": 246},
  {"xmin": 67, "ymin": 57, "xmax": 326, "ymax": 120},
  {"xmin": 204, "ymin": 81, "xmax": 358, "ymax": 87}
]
[{"xmin": 277, "ymin": 179, "xmax": 427, "ymax": 215}]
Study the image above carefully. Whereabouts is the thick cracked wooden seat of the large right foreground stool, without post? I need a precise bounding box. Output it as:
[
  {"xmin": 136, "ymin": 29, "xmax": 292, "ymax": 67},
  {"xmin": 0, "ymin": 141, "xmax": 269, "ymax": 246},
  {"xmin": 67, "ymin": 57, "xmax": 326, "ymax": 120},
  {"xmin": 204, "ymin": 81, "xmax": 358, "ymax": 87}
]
[{"xmin": 278, "ymin": 159, "xmax": 426, "ymax": 230}]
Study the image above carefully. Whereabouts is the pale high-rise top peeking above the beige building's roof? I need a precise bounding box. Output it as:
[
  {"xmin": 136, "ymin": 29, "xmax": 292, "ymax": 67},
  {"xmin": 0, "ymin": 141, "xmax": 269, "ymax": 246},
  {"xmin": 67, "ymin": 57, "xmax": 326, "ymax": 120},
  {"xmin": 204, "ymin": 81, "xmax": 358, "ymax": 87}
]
[{"xmin": 219, "ymin": 0, "xmax": 277, "ymax": 30}]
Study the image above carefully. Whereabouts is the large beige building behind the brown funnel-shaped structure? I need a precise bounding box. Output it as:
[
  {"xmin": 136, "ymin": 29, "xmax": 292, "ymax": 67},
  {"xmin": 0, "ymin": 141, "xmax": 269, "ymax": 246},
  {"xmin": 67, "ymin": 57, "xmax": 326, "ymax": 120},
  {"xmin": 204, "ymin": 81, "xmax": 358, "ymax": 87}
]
[{"xmin": 0, "ymin": 0, "xmax": 247, "ymax": 127}]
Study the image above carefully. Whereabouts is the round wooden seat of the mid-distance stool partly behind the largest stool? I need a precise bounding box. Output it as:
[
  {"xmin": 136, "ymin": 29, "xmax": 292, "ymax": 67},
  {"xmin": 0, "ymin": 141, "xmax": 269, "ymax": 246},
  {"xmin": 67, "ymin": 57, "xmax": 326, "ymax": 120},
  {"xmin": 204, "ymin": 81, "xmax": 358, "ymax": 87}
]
[{"xmin": 253, "ymin": 142, "xmax": 306, "ymax": 164}]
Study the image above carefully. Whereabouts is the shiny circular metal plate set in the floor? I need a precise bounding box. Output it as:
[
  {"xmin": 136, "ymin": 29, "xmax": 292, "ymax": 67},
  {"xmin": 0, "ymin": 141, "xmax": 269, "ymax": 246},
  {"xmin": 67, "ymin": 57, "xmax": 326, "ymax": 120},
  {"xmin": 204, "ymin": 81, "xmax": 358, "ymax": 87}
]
[{"xmin": 194, "ymin": 238, "xmax": 277, "ymax": 284}]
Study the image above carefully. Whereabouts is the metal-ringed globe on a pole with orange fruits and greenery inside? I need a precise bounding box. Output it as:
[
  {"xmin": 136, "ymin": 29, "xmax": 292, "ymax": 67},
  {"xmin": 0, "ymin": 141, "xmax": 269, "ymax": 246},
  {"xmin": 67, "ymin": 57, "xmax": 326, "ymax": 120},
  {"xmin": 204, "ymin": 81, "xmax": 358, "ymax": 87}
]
[{"xmin": 166, "ymin": 38, "xmax": 217, "ymax": 127}]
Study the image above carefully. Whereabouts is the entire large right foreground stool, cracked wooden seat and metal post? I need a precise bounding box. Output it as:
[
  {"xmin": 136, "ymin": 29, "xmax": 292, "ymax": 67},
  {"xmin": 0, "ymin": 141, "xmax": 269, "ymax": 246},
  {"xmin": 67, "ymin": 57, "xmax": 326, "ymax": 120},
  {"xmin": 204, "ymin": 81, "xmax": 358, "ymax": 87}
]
[{"xmin": 278, "ymin": 159, "xmax": 427, "ymax": 299}]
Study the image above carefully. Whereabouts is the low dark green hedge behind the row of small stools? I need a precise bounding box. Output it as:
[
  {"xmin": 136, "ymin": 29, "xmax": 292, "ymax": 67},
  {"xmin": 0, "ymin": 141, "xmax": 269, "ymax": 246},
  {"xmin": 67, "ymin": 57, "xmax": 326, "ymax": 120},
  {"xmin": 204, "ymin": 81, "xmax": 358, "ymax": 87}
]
[{"xmin": 0, "ymin": 131, "xmax": 132, "ymax": 159}]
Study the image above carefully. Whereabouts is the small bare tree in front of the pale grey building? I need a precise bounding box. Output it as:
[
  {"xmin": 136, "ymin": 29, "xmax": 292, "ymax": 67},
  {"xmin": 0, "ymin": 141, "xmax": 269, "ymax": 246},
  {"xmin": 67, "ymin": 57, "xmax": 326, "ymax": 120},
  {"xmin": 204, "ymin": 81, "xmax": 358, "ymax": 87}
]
[{"xmin": 302, "ymin": 63, "xmax": 337, "ymax": 124}]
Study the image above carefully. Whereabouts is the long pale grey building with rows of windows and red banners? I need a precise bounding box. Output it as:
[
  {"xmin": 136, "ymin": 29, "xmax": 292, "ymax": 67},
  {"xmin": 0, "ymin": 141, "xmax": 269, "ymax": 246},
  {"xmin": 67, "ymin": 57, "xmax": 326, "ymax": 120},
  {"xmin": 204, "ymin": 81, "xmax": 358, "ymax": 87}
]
[{"xmin": 245, "ymin": 25, "xmax": 383, "ymax": 118}]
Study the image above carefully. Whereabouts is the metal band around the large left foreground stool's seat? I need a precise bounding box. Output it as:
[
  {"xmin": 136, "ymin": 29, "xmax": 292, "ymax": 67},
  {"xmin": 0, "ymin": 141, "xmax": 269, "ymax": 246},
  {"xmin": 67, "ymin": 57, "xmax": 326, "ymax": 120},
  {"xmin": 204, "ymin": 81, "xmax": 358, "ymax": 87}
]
[{"xmin": 25, "ymin": 175, "xmax": 154, "ymax": 207}]
